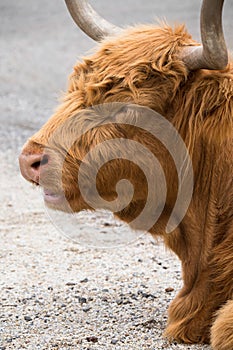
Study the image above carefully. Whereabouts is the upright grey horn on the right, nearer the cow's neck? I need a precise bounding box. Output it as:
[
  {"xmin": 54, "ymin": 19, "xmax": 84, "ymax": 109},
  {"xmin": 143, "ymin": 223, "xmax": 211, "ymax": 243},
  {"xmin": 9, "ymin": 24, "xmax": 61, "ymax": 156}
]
[{"xmin": 181, "ymin": 0, "xmax": 228, "ymax": 70}]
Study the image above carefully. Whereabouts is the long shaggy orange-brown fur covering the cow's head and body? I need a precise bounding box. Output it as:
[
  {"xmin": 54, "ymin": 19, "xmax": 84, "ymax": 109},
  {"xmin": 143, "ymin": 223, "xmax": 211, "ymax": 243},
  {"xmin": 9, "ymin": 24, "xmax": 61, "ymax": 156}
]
[{"xmin": 20, "ymin": 25, "xmax": 233, "ymax": 350}]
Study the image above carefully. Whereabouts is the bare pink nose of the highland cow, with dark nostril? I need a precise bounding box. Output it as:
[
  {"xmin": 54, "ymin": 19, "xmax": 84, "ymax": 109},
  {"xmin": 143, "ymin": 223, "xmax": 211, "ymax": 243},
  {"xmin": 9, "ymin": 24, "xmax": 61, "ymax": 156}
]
[{"xmin": 19, "ymin": 153, "xmax": 49, "ymax": 184}]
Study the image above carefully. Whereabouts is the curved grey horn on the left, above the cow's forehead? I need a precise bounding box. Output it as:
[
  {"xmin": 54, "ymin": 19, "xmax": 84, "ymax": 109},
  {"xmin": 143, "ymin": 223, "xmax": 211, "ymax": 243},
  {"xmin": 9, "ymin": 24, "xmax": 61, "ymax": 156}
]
[{"xmin": 65, "ymin": 0, "xmax": 121, "ymax": 41}]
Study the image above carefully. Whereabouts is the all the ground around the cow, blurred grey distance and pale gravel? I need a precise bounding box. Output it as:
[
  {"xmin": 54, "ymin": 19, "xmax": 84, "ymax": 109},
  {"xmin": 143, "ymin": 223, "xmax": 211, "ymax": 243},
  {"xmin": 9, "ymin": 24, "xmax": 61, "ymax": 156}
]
[{"xmin": 0, "ymin": 0, "xmax": 232, "ymax": 350}]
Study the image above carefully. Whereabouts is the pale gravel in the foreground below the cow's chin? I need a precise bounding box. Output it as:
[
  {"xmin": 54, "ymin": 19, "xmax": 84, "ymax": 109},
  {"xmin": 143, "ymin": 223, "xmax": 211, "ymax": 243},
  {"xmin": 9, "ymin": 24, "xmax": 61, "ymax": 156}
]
[{"xmin": 0, "ymin": 152, "xmax": 209, "ymax": 350}]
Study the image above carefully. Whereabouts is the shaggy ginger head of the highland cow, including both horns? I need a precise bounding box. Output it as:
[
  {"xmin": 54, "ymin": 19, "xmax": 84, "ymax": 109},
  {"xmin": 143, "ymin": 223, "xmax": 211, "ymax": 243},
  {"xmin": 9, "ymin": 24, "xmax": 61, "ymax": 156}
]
[{"xmin": 20, "ymin": 0, "xmax": 228, "ymax": 221}]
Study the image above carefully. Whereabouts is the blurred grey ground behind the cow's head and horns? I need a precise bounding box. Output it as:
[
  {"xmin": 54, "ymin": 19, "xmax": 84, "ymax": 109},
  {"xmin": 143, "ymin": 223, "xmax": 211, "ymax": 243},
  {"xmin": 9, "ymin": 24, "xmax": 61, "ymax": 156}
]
[{"xmin": 0, "ymin": 0, "xmax": 233, "ymax": 152}]
